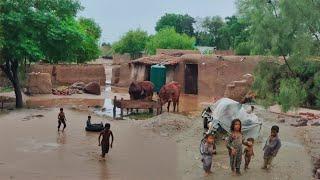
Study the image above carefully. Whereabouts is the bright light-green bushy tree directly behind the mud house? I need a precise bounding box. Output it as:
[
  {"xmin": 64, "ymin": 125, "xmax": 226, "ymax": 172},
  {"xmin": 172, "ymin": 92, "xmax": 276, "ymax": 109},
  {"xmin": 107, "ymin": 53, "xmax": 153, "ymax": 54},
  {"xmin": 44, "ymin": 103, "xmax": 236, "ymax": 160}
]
[{"xmin": 146, "ymin": 28, "xmax": 196, "ymax": 54}]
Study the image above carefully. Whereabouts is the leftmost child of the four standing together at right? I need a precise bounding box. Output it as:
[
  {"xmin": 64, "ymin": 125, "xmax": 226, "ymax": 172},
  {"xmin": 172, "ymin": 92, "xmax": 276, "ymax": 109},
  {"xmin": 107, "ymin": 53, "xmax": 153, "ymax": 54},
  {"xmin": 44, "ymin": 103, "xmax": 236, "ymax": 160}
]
[{"xmin": 200, "ymin": 133, "xmax": 216, "ymax": 176}]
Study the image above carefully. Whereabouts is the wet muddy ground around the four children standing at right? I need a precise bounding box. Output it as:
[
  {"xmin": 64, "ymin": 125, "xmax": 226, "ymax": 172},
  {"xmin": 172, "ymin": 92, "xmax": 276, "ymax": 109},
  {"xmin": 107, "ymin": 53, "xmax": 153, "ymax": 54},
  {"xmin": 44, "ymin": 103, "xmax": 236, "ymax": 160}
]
[{"xmin": 176, "ymin": 106, "xmax": 312, "ymax": 180}]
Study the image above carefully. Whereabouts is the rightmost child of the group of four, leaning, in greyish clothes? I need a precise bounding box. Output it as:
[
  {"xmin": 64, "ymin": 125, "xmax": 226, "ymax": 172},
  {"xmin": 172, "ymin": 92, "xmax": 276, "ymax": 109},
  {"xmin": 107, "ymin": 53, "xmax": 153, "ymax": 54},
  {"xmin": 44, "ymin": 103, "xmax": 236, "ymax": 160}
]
[{"xmin": 262, "ymin": 126, "xmax": 281, "ymax": 169}]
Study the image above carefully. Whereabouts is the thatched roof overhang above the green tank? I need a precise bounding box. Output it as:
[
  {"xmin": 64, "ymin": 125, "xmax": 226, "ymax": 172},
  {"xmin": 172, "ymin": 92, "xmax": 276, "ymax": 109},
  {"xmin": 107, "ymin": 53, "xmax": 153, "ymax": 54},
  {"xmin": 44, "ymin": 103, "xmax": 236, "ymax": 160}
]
[{"xmin": 130, "ymin": 54, "xmax": 181, "ymax": 65}]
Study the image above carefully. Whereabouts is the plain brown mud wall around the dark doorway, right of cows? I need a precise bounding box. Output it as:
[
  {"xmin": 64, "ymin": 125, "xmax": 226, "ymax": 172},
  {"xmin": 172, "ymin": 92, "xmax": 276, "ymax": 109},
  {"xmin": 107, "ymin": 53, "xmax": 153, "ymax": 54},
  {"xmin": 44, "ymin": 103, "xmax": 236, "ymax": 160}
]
[{"xmin": 176, "ymin": 56, "xmax": 261, "ymax": 97}]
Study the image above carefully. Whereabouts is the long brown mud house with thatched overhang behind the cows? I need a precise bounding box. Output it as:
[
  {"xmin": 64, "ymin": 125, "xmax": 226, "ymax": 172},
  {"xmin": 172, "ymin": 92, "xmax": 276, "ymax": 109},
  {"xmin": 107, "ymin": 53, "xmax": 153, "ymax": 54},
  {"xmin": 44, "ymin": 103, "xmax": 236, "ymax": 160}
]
[{"xmin": 114, "ymin": 53, "xmax": 262, "ymax": 97}]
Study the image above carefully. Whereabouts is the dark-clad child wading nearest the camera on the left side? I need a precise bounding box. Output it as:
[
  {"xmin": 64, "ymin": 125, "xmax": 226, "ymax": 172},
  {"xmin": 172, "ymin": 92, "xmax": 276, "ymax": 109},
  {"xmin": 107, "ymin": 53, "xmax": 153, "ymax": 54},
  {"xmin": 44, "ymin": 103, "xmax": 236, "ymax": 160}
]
[{"xmin": 99, "ymin": 123, "xmax": 113, "ymax": 158}]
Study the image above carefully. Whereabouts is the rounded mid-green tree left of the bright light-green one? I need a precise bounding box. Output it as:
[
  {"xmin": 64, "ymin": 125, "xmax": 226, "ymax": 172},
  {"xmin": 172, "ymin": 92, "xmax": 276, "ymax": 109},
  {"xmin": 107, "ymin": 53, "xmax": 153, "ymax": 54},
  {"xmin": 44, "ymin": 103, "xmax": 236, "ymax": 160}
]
[{"xmin": 112, "ymin": 29, "xmax": 149, "ymax": 59}]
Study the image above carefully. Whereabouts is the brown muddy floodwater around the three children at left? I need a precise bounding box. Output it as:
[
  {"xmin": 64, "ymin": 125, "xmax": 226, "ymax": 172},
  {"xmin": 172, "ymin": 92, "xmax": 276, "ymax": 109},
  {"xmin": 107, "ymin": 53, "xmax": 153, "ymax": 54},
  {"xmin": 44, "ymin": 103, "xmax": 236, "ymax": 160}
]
[{"xmin": 0, "ymin": 109, "xmax": 177, "ymax": 179}]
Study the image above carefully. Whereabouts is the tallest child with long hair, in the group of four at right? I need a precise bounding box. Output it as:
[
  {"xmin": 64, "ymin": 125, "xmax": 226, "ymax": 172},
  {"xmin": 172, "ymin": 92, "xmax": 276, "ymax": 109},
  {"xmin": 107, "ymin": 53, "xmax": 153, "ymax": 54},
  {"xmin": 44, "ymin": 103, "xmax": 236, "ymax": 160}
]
[{"xmin": 227, "ymin": 119, "xmax": 244, "ymax": 175}]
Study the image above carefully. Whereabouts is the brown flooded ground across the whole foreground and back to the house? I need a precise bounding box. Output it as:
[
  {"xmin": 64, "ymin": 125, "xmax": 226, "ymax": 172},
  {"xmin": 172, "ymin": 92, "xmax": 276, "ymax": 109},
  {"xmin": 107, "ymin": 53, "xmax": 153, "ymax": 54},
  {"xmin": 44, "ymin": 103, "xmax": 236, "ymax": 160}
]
[{"xmin": 0, "ymin": 61, "xmax": 312, "ymax": 180}]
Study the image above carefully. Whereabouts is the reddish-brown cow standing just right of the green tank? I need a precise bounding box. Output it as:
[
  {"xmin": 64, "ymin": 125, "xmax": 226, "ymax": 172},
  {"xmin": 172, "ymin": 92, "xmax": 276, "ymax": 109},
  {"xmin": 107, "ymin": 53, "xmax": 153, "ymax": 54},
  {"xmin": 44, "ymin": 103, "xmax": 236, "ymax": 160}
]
[{"xmin": 159, "ymin": 81, "xmax": 181, "ymax": 112}]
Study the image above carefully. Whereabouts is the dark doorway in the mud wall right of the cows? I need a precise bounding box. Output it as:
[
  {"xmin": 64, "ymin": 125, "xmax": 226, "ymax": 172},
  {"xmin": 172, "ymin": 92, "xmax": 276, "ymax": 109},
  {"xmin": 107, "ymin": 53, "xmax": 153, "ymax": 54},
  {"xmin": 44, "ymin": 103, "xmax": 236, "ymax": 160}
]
[{"xmin": 184, "ymin": 64, "xmax": 198, "ymax": 94}]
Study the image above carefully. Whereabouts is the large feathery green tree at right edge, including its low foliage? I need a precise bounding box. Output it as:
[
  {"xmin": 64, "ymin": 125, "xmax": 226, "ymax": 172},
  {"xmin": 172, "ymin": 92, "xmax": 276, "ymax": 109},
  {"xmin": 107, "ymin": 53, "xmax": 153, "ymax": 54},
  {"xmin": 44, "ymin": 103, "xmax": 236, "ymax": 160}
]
[{"xmin": 237, "ymin": 0, "xmax": 320, "ymax": 110}]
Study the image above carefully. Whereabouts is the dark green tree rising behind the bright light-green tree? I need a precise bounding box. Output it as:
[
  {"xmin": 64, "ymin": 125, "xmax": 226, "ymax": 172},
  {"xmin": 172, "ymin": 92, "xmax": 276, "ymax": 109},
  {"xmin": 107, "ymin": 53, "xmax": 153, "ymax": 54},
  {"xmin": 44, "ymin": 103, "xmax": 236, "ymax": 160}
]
[{"xmin": 155, "ymin": 13, "xmax": 195, "ymax": 36}]
